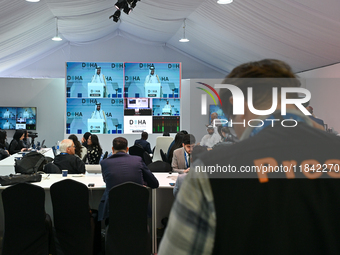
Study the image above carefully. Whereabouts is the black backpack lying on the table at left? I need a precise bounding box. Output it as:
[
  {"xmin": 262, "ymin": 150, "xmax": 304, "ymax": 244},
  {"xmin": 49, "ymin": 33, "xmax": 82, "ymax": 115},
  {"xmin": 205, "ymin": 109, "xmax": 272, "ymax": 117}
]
[{"xmin": 14, "ymin": 151, "xmax": 47, "ymax": 174}]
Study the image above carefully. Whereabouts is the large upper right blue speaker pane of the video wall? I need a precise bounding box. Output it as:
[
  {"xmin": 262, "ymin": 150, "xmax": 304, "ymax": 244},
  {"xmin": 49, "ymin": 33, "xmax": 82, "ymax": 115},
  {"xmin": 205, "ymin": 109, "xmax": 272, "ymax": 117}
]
[{"xmin": 124, "ymin": 63, "xmax": 181, "ymax": 98}]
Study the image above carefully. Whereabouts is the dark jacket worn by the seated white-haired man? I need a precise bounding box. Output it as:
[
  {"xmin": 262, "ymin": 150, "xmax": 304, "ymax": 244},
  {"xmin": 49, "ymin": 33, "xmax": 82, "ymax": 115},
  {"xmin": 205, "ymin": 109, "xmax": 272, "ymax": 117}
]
[{"xmin": 53, "ymin": 153, "xmax": 85, "ymax": 174}]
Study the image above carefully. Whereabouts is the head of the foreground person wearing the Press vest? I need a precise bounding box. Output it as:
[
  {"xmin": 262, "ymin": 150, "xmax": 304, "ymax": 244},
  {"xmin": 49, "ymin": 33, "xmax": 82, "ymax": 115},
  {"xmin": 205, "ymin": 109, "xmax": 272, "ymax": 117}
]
[{"xmin": 220, "ymin": 59, "xmax": 300, "ymax": 137}]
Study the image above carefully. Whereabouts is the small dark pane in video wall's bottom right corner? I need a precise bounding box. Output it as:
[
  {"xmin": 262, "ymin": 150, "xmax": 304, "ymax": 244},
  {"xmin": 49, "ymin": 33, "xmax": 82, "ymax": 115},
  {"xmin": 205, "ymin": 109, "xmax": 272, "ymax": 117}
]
[{"xmin": 152, "ymin": 116, "xmax": 180, "ymax": 133}]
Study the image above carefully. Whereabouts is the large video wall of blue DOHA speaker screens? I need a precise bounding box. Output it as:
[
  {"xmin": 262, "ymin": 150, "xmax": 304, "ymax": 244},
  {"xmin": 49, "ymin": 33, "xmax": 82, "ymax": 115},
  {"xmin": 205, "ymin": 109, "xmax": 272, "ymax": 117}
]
[{"xmin": 66, "ymin": 62, "xmax": 181, "ymax": 134}]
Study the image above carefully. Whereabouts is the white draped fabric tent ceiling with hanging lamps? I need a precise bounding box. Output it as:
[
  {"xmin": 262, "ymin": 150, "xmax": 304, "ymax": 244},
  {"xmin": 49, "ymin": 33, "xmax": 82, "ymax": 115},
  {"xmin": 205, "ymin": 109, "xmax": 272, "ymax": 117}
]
[{"xmin": 0, "ymin": 0, "xmax": 340, "ymax": 76}]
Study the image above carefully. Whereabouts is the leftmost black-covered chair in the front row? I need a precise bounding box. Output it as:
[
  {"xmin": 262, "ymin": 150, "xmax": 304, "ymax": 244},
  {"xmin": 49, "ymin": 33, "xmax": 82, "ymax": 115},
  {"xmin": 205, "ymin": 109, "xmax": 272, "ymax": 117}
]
[{"xmin": 2, "ymin": 183, "xmax": 55, "ymax": 255}]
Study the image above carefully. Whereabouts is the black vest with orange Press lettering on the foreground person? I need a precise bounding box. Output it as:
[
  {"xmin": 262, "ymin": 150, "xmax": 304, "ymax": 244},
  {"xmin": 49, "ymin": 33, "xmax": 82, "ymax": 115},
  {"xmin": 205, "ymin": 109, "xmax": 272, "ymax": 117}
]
[{"xmin": 203, "ymin": 123, "xmax": 340, "ymax": 254}]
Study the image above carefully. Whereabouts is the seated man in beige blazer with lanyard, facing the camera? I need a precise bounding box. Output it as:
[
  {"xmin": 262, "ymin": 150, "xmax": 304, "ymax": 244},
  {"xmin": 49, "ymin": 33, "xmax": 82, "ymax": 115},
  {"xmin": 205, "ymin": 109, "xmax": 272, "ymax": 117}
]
[{"xmin": 171, "ymin": 134, "xmax": 196, "ymax": 174}]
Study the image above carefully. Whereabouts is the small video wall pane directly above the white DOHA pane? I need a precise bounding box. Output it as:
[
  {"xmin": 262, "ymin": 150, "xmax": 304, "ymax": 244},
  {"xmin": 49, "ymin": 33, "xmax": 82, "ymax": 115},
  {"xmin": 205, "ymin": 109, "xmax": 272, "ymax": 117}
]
[{"xmin": 124, "ymin": 98, "xmax": 152, "ymax": 116}]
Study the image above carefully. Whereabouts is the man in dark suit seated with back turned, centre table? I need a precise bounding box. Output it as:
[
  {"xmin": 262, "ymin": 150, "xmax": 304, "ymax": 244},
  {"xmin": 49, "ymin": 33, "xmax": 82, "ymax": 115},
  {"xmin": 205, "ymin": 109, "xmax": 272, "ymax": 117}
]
[{"xmin": 98, "ymin": 137, "xmax": 159, "ymax": 220}]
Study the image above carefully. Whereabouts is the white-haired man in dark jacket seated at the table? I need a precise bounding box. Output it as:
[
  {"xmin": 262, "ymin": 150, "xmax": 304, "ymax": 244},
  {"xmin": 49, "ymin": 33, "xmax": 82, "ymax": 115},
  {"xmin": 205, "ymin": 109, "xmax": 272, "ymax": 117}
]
[{"xmin": 53, "ymin": 139, "xmax": 85, "ymax": 174}]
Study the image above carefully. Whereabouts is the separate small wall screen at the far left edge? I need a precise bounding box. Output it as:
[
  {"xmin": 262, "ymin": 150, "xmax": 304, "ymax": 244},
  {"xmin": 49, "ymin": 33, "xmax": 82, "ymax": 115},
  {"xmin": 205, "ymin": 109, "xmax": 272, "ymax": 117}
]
[{"xmin": 0, "ymin": 107, "xmax": 37, "ymax": 130}]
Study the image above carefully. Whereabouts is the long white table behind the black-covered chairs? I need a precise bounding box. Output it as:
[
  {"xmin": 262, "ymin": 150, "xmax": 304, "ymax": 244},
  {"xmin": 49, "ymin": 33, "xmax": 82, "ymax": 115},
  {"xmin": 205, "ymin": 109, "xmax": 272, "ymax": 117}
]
[{"xmin": 0, "ymin": 167, "xmax": 177, "ymax": 253}]
